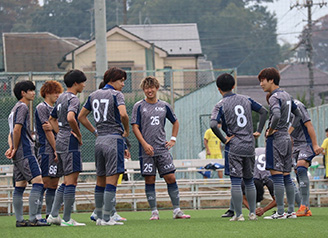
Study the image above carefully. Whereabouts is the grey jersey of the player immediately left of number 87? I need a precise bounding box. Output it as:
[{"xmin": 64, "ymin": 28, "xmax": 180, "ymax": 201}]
[{"xmin": 51, "ymin": 92, "xmax": 80, "ymax": 153}]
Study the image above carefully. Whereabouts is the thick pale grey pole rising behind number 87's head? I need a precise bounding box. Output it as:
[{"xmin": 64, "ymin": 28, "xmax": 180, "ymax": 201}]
[{"xmin": 94, "ymin": 0, "xmax": 108, "ymax": 88}]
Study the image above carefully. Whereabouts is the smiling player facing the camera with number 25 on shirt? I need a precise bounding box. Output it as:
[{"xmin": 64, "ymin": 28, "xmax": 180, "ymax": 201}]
[{"xmin": 131, "ymin": 76, "xmax": 190, "ymax": 220}]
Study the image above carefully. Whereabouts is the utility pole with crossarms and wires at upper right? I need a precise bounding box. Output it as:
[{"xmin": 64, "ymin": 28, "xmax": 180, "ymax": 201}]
[{"xmin": 290, "ymin": 0, "xmax": 327, "ymax": 106}]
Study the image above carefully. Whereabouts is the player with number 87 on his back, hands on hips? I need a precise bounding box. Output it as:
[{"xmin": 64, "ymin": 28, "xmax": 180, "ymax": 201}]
[{"xmin": 78, "ymin": 67, "xmax": 130, "ymax": 226}]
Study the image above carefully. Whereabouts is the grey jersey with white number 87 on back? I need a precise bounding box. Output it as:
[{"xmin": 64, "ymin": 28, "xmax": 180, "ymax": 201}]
[{"xmin": 84, "ymin": 88, "xmax": 125, "ymax": 135}]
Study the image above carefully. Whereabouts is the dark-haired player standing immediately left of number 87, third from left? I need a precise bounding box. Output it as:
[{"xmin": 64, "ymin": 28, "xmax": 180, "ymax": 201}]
[{"xmin": 47, "ymin": 69, "xmax": 87, "ymax": 226}]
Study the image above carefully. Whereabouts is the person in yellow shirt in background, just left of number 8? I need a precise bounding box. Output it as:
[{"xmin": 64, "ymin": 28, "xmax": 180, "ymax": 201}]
[{"xmin": 204, "ymin": 129, "xmax": 223, "ymax": 178}]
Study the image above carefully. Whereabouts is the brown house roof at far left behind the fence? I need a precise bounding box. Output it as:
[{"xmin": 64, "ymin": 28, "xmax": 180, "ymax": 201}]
[{"xmin": 2, "ymin": 32, "xmax": 82, "ymax": 72}]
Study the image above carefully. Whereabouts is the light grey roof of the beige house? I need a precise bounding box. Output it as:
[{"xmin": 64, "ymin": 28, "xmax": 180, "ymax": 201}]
[{"xmin": 120, "ymin": 23, "xmax": 202, "ymax": 55}]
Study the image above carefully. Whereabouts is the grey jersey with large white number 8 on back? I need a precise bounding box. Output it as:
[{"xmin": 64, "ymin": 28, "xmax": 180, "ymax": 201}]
[{"xmin": 211, "ymin": 93, "xmax": 262, "ymax": 156}]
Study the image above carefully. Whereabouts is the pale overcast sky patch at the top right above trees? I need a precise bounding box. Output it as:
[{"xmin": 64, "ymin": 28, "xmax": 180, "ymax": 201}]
[{"xmin": 265, "ymin": 0, "xmax": 328, "ymax": 44}]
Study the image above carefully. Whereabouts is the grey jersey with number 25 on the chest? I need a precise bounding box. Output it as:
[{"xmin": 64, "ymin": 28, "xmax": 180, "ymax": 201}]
[{"xmin": 131, "ymin": 100, "xmax": 177, "ymax": 156}]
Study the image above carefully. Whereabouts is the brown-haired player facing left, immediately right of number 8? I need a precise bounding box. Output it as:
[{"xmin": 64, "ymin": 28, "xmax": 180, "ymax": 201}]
[{"xmin": 258, "ymin": 67, "xmax": 300, "ymax": 219}]
